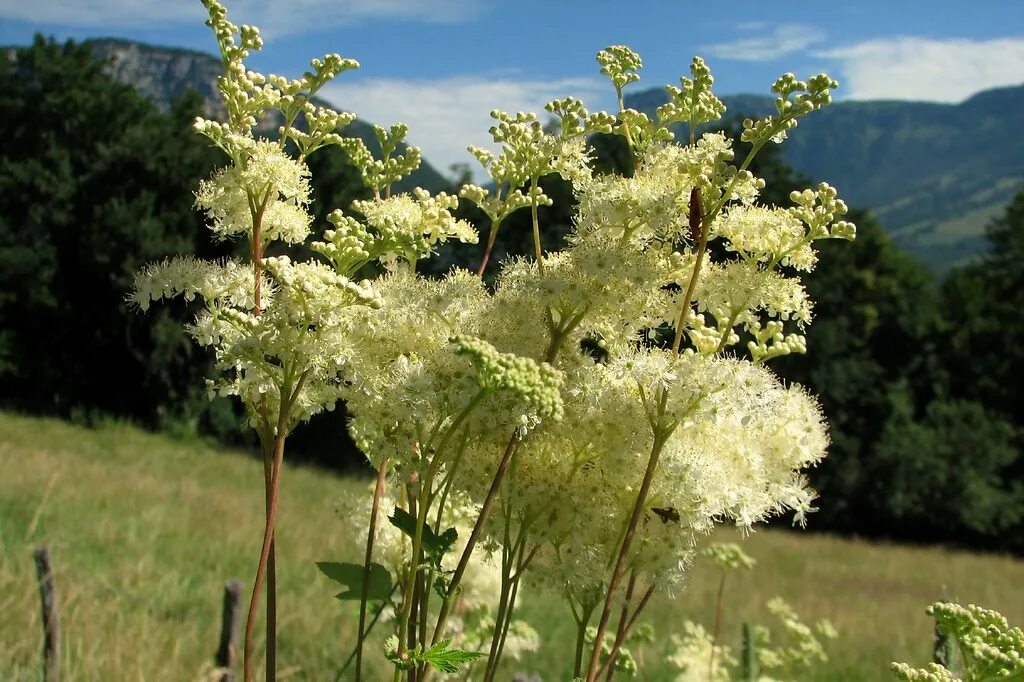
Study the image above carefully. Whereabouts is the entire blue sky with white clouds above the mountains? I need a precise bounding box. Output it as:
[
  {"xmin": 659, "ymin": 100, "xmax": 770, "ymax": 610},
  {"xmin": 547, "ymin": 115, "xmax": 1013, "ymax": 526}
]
[{"xmin": 0, "ymin": 0, "xmax": 1024, "ymax": 176}]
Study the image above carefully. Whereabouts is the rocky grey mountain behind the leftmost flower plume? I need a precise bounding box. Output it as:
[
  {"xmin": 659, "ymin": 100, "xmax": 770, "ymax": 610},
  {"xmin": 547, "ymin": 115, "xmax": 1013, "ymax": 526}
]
[{"xmin": 85, "ymin": 38, "xmax": 451, "ymax": 191}]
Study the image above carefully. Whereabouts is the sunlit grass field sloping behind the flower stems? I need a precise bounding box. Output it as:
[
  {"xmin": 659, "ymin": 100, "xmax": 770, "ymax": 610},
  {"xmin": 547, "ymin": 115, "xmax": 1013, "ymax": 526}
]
[{"xmin": 0, "ymin": 415, "xmax": 1024, "ymax": 682}]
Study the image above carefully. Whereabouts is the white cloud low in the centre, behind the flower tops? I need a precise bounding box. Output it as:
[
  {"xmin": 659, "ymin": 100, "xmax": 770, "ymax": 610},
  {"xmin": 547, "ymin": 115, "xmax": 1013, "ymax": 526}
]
[{"xmin": 321, "ymin": 75, "xmax": 608, "ymax": 181}]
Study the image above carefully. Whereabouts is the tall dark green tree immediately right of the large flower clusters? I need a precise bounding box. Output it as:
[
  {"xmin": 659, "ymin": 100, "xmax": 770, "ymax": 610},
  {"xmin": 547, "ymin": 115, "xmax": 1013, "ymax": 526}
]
[{"xmin": 775, "ymin": 212, "xmax": 941, "ymax": 534}]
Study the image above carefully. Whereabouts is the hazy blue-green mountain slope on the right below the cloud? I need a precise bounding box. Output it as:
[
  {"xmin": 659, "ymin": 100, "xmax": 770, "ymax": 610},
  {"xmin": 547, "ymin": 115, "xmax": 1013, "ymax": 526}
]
[{"xmin": 626, "ymin": 85, "xmax": 1024, "ymax": 270}]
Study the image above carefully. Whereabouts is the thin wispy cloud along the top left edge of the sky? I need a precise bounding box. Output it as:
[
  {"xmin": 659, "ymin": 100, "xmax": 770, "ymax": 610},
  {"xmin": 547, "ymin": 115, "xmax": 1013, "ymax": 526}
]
[{"xmin": 0, "ymin": 0, "xmax": 482, "ymax": 34}]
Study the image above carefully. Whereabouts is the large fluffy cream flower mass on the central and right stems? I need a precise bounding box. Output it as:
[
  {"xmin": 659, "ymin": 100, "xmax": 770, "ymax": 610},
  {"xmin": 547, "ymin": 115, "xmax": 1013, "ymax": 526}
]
[{"xmin": 307, "ymin": 38, "xmax": 853, "ymax": 663}]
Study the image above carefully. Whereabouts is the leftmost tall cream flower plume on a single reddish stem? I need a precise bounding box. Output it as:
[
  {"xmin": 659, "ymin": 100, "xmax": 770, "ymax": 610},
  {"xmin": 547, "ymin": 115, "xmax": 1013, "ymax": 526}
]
[{"xmin": 132, "ymin": 0, "xmax": 380, "ymax": 432}]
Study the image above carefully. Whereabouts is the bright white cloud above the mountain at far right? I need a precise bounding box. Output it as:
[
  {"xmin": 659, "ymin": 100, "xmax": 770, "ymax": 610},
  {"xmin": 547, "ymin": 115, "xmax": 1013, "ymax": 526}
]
[{"xmin": 819, "ymin": 36, "xmax": 1024, "ymax": 102}]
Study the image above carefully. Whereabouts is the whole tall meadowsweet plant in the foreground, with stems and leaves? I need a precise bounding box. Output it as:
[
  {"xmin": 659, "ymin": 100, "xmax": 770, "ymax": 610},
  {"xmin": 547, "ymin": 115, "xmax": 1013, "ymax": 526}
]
[{"xmin": 133, "ymin": 0, "xmax": 855, "ymax": 682}]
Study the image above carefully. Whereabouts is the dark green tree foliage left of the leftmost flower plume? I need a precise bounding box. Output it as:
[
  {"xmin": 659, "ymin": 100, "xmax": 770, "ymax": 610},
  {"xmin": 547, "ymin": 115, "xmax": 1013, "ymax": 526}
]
[{"xmin": 0, "ymin": 37, "xmax": 237, "ymax": 432}]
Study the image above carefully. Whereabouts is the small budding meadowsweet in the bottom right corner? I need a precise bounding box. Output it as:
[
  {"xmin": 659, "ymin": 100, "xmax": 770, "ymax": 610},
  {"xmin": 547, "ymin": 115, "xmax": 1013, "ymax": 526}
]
[{"xmin": 892, "ymin": 602, "xmax": 1024, "ymax": 682}]
